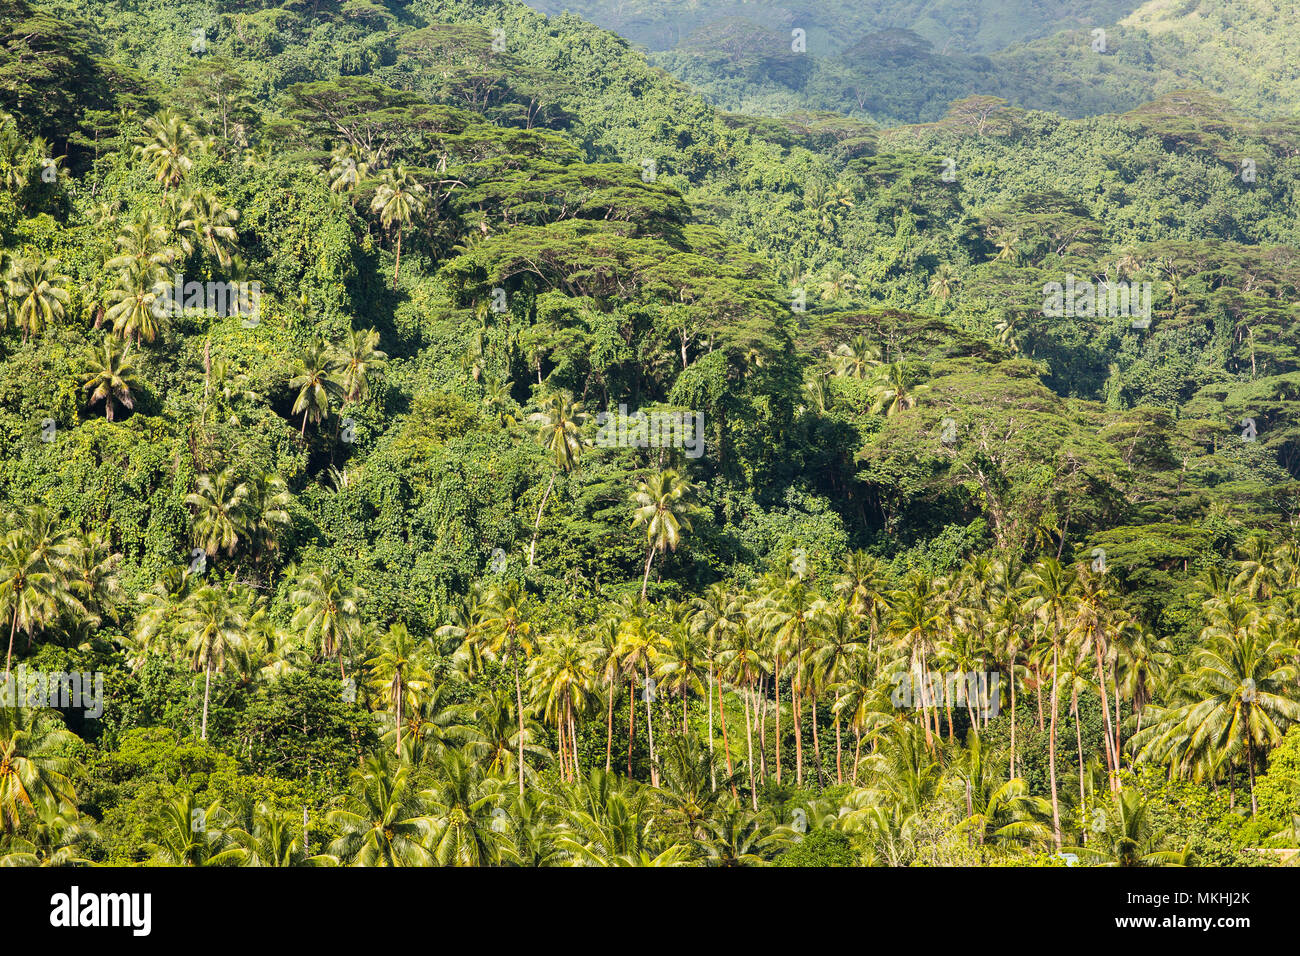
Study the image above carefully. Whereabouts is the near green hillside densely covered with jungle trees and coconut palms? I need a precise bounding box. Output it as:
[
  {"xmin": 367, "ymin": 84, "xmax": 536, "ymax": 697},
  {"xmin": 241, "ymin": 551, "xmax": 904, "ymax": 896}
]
[{"xmin": 0, "ymin": 0, "xmax": 1300, "ymax": 866}]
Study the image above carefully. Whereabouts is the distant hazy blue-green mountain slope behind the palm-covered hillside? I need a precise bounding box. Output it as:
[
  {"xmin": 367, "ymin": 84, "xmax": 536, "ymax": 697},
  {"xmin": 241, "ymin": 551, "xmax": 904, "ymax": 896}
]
[{"xmin": 532, "ymin": 0, "xmax": 1300, "ymax": 125}]
